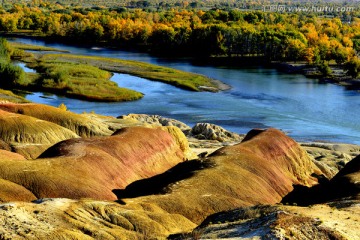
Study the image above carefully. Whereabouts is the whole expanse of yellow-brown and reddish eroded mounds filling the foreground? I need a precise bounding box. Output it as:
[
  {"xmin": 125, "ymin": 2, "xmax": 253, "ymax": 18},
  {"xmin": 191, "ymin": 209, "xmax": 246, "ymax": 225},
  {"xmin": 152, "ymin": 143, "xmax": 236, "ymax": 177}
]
[{"xmin": 0, "ymin": 104, "xmax": 359, "ymax": 239}]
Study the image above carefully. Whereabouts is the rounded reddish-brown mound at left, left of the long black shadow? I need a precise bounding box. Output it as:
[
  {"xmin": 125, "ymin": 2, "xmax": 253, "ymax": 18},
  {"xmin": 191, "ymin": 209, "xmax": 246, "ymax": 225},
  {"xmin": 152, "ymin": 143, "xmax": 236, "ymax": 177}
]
[{"xmin": 0, "ymin": 127, "xmax": 184, "ymax": 200}]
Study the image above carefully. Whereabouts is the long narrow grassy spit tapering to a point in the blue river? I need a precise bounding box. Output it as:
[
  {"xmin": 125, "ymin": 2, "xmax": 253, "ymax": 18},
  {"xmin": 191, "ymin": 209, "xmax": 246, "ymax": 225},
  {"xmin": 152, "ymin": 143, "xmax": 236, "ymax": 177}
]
[{"xmin": 42, "ymin": 54, "xmax": 218, "ymax": 91}]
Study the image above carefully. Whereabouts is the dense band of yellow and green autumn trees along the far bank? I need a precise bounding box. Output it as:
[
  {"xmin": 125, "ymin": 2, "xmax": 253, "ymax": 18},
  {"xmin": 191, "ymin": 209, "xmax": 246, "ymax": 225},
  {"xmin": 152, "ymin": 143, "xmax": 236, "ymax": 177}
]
[{"xmin": 0, "ymin": 1, "xmax": 360, "ymax": 77}]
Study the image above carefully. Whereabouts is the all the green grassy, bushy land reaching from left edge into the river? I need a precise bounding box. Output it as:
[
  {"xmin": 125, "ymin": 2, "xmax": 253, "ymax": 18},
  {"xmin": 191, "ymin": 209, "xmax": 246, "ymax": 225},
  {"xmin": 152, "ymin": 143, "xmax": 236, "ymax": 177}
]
[{"xmin": 0, "ymin": 39, "xmax": 224, "ymax": 102}]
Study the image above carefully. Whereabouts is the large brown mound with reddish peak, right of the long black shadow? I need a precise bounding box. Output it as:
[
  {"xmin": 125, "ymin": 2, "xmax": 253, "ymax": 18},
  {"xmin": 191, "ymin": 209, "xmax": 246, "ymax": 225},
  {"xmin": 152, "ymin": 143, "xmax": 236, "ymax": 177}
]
[{"xmin": 117, "ymin": 129, "xmax": 319, "ymax": 223}]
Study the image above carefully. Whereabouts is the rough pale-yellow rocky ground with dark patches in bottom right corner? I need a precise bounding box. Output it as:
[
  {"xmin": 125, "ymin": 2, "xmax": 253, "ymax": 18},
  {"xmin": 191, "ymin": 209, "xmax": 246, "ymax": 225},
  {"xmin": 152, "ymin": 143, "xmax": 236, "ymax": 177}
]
[{"xmin": 177, "ymin": 202, "xmax": 360, "ymax": 240}]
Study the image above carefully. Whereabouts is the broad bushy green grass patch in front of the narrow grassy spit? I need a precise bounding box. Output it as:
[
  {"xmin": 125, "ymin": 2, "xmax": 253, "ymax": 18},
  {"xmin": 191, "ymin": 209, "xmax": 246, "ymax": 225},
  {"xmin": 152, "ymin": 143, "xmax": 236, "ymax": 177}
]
[{"xmin": 27, "ymin": 59, "xmax": 143, "ymax": 102}]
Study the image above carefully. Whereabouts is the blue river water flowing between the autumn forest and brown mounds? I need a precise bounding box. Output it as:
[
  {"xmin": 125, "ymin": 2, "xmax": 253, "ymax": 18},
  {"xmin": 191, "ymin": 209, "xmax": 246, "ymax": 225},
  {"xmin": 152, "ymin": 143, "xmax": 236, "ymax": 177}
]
[{"xmin": 11, "ymin": 39, "xmax": 360, "ymax": 144}]
